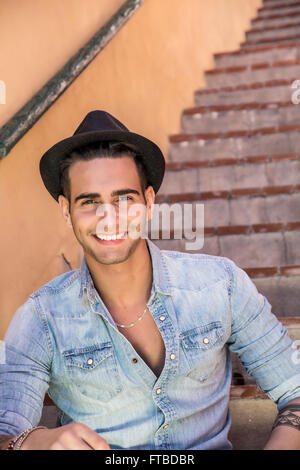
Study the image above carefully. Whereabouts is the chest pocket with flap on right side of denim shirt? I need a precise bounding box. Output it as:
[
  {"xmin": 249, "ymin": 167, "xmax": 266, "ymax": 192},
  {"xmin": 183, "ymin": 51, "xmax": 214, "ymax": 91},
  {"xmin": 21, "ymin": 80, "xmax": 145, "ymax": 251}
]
[{"xmin": 180, "ymin": 322, "xmax": 224, "ymax": 382}]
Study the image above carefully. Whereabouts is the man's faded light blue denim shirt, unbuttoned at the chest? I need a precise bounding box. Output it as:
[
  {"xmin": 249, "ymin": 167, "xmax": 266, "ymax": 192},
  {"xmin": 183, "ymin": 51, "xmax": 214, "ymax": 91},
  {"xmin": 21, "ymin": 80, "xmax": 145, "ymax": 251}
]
[{"xmin": 0, "ymin": 240, "xmax": 300, "ymax": 450}]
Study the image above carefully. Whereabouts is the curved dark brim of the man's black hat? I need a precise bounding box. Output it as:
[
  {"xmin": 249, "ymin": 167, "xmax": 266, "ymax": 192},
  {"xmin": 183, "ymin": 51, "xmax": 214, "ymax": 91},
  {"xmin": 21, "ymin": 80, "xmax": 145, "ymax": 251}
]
[{"xmin": 40, "ymin": 131, "xmax": 165, "ymax": 201}]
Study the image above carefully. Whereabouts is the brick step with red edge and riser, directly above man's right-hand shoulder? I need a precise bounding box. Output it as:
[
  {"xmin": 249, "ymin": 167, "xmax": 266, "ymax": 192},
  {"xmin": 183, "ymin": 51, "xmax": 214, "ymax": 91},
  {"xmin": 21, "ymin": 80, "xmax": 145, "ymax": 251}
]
[{"xmin": 152, "ymin": 222, "xmax": 300, "ymax": 268}]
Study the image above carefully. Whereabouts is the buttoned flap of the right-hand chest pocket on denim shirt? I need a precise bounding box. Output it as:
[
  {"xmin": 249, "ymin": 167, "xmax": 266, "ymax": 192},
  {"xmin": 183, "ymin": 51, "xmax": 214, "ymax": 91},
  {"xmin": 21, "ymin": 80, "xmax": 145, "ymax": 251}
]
[{"xmin": 180, "ymin": 322, "xmax": 224, "ymax": 349}]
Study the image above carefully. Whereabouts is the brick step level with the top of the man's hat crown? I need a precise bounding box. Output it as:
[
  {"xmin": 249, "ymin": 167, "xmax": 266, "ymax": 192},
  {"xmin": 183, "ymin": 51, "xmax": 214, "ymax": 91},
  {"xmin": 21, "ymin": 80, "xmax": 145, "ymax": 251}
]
[{"xmin": 181, "ymin": 100, "xmax": 300, "ymax": 134}]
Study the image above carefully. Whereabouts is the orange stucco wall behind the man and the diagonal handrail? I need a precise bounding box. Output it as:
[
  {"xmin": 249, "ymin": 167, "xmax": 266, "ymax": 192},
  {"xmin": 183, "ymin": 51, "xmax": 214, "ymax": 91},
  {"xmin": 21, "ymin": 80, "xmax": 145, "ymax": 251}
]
[{"xmin": 0, "ymin": 0, "xmax": 261, "ymax": 338}]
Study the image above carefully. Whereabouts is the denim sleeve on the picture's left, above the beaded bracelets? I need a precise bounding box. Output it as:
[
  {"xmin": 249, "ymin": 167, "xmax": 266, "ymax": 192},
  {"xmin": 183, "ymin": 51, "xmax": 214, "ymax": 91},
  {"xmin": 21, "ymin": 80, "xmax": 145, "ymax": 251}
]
[{"xmin": 0, "ymin": 297, "xmax": 52, "ymax": 435}]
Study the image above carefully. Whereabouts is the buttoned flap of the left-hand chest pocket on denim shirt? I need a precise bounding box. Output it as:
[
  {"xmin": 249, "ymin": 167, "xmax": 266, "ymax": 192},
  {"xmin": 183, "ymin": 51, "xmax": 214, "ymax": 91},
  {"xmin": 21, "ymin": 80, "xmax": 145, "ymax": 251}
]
[{"xmin": 63, "ymin": 342, "xmax": 113, "ymax": 369}]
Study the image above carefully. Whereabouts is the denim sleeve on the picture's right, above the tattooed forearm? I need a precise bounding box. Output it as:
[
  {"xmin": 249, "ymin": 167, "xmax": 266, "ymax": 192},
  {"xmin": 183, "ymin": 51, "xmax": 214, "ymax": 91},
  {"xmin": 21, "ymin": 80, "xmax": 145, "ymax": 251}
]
[{"xmin": 228, "ymin": 260, "xmax": 300, "ymax": 409}]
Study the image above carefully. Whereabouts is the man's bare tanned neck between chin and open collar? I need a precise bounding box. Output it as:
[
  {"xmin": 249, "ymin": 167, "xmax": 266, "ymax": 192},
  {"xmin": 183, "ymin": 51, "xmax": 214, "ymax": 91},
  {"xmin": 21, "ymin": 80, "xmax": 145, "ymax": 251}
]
[{"xmin": 86, "ymin": 240, "xmax": 153, "ymax": 312}]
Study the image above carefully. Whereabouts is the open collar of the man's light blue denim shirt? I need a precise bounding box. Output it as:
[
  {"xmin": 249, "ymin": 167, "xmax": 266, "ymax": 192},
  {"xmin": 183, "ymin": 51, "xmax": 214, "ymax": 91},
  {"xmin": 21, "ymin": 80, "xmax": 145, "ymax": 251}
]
[{"xmin": 79, "ymin": 239, "xmax": 171, "ymax": 303}]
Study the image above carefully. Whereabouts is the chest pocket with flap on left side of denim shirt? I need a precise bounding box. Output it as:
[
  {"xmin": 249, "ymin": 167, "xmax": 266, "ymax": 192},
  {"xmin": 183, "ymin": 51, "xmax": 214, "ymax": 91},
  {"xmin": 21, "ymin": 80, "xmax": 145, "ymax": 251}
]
[{"xmin": 63, "ymin": 342, "xmax": 122, "ymax": 402}]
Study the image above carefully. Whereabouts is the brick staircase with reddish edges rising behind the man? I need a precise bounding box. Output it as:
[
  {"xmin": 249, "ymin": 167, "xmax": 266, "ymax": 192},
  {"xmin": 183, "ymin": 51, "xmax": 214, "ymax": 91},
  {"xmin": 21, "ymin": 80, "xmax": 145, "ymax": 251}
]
[{"xmin": 153, "ymin": 0, "xmax": 300, "ymax": 449}]
